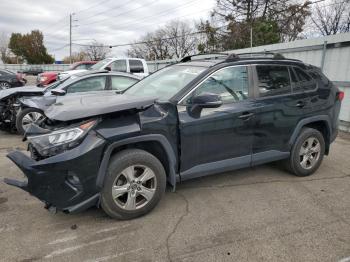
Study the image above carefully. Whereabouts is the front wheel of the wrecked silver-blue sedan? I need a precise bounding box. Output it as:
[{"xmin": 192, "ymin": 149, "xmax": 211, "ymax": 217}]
[{"xmin": 16, "ymin": 107, "xmax": 45, "ymax": 135}]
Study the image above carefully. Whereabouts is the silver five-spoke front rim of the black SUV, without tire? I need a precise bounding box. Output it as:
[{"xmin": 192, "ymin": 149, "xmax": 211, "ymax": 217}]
[{"xmin": 112, "ymin": 165, "xmax": 157, "ymax": 211}]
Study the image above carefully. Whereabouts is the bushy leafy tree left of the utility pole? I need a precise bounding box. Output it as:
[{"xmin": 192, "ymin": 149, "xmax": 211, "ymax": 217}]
[{"xmin": 9, "ymin": 30, "xmax": 55, "ymax": 64}]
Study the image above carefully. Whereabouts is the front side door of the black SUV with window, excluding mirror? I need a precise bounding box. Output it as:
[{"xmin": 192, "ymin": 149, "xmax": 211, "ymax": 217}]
[{"xmin": 178, "ymin": 66, "xmax": 254, "ymax": 180}]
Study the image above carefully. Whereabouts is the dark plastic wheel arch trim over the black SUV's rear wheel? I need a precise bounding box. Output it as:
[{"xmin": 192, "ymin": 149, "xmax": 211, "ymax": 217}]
[{"xmin": 289, "ymin": 115, "xmax": 332, "ymax": 155}]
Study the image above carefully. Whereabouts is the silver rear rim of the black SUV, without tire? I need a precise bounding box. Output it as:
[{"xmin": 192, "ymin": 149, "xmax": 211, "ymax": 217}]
[{"xmin": 299, "ymin": 136, "xmax": 321, "ymax": 169}]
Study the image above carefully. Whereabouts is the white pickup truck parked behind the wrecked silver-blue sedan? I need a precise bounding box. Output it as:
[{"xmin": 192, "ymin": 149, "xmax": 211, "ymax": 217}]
[{"xmin": 58, "ymin": 57, "xmax": 149, "ymax": 79}]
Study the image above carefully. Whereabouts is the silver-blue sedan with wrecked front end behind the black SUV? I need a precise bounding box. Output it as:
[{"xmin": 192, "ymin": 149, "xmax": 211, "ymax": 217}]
[{"xmin": 0, "ymin": 71, "xmax": 141, "ymax": 134}]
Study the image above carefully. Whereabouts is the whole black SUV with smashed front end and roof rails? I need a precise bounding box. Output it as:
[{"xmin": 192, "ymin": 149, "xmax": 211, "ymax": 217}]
[{"xmin": 5, "ymin": 54, "xmax": 343, "ymax": 219}]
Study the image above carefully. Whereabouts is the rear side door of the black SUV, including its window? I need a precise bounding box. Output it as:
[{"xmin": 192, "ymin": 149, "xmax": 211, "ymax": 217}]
[{"xmin": 252, "ymin": 64, "xmax": 305, "ymax": 164}]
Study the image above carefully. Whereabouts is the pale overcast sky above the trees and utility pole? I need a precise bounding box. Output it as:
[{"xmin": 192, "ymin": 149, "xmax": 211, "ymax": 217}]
[{"xmin": 0, "ymin": 0, "xmax": 215, "ymax": 60}]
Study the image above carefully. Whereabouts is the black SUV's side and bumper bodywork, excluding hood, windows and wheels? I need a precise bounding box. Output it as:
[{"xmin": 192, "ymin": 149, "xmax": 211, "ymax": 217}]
[{"xmin": 3, "ymin": 57, "xmax": 340, "ymax": 211}]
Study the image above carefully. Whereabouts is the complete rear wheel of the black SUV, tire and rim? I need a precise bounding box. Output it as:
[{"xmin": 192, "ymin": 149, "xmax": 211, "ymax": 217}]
[{"xmin": 285, "ymin": 128, "xmax": 325, "ymax": 177}]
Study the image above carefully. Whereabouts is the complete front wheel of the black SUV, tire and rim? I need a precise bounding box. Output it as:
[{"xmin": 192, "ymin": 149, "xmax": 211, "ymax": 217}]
[{"xmin": 101, "ymin": 149, "xmax": 166, "ymax": 219}]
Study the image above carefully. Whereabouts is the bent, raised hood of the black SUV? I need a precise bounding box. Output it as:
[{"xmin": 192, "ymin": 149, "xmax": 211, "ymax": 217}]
[{"xmin": 44, "ymin": 94, "xmax": 156, "ymax": 121}]
